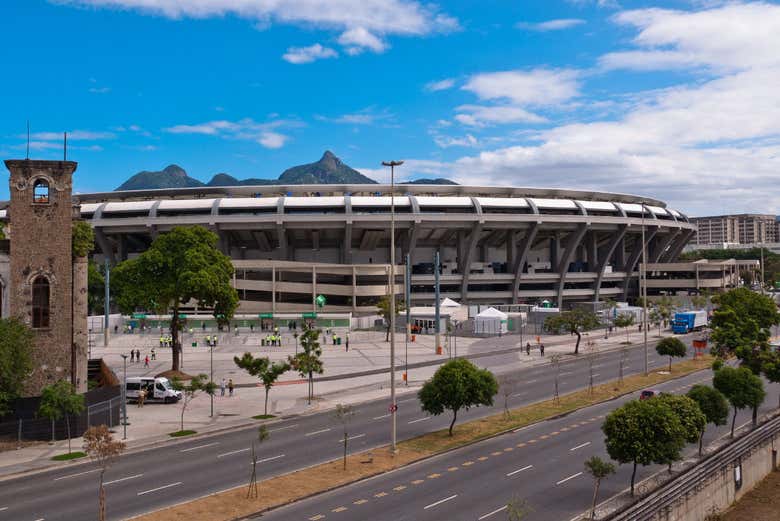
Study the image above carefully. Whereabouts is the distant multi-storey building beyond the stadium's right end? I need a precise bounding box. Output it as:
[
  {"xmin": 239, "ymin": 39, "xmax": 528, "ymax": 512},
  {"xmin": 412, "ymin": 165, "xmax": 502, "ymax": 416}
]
[{"xmin": 690, "ymin": 214, "xmax": 778, "ymax": 247}]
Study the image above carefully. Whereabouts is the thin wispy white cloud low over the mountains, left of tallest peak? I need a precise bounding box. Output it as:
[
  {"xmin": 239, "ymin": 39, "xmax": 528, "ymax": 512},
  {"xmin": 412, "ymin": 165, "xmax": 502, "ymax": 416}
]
[{"xmin": 164, "ymin": 118, "xmax": 301, "ymax": 149}]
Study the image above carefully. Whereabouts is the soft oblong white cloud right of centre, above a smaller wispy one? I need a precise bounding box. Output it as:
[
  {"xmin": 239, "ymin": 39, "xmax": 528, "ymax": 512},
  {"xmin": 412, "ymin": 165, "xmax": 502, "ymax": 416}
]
[{"xmin": 462, "ymin": 69, "xmax": 580, "ymax": 106}]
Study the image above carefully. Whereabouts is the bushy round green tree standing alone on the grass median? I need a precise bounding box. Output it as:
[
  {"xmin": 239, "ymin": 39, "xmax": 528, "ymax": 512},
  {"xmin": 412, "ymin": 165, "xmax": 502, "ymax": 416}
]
[{"xmin": 418, "ymin": 358, "xmax": 498, "ymax": 436}]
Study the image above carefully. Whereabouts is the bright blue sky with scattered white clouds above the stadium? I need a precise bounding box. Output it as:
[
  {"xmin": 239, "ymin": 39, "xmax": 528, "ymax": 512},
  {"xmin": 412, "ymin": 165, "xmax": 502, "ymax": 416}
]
[{"xmin": 0, "ymin": 0, "xmax": 780, "ymax": 215}]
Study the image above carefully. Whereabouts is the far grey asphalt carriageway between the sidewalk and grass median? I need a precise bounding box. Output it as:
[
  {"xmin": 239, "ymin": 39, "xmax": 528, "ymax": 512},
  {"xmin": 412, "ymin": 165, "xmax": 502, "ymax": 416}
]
[{"xmin": 0, "ymin": 336, "xmax": 774, "ymax": 521}]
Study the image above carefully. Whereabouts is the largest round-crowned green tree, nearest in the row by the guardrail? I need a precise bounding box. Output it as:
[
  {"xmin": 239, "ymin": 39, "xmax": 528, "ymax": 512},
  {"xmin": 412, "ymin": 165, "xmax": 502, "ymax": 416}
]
[{"xmin": 601, "ymin": 399, "xmax": 686, "ymax": 496}]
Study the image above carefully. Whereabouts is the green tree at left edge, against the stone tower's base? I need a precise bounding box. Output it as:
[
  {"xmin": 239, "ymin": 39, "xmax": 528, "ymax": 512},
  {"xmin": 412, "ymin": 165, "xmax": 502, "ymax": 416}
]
[{"xmin": 0, "ymin": 318, "xmax": 35, "ymax": 417}]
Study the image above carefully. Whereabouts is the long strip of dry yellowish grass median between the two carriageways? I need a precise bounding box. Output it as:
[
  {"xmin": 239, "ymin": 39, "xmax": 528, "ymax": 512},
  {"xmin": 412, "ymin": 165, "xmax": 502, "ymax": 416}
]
[{"xmin": 134, "ymin": 356, "xmax": 712, "ymax": 521}]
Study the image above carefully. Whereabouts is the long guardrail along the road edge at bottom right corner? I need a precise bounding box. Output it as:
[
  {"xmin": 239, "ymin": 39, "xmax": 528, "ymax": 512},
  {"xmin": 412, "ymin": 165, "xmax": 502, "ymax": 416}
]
[{"xmin": 604, "ymin": 415, "xmax": 780, "ymax": 521}]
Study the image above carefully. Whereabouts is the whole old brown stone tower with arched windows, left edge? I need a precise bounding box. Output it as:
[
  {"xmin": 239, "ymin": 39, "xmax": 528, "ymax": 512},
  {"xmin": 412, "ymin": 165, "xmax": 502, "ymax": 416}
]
[{"xmin": 5, "ymin": 160, "xmax": 87, "ymax": 395}]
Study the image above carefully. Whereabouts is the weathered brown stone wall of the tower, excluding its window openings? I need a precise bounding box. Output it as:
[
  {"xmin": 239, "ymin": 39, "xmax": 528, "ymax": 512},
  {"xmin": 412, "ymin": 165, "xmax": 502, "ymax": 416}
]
[{"xmin": 5, "ymin": 160, "xmax": 77, "ymax": 396}]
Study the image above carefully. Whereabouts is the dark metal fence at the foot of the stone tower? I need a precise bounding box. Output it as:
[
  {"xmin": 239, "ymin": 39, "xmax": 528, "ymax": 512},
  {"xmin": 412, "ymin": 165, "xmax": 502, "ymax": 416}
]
[{"xmin": 0, "ymin": 396, "xmax": 122, "ymax": 445}]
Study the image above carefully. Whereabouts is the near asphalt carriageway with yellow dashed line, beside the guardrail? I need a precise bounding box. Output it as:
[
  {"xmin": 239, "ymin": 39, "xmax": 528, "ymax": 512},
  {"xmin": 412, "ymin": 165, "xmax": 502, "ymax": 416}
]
[{"xmin": 257, "ymin": 371, "xmax": 780, "ymax": 521}]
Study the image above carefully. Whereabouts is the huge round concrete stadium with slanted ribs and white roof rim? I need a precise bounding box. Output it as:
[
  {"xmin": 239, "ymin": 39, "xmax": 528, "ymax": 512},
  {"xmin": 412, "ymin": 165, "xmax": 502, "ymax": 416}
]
[{"xmin": 12, "ymin": 185, "xmax": 696, "ymax": 314}]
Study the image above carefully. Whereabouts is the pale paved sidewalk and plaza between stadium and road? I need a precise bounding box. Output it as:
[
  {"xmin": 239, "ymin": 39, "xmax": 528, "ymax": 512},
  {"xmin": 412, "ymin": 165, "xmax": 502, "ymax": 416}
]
[{"xmin": 0, "ymin": 328, "xmax": 671, "ymax": 477}]
